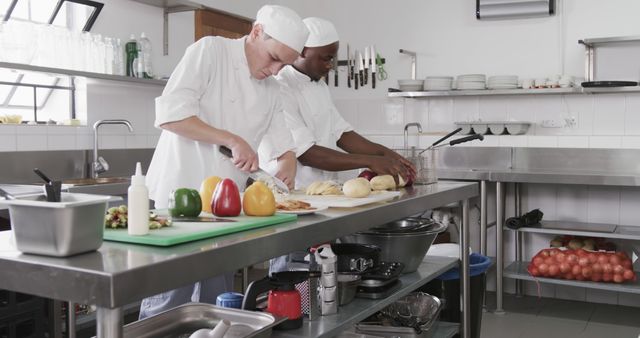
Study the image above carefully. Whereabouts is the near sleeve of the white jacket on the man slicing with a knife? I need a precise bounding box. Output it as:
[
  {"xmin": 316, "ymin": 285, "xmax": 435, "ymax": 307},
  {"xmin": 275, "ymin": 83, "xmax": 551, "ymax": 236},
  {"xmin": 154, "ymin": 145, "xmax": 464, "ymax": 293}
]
[{"xmin": 154, "ymin": 38, "xmax": 216, "ymax": 128}]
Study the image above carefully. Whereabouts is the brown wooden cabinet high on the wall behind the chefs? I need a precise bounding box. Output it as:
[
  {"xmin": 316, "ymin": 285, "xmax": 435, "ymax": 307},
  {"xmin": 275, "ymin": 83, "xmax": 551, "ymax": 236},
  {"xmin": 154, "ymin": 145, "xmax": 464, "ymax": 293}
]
[{"xmin": 195, "ymin": 9, "xmax": 253, "ymax": 41}]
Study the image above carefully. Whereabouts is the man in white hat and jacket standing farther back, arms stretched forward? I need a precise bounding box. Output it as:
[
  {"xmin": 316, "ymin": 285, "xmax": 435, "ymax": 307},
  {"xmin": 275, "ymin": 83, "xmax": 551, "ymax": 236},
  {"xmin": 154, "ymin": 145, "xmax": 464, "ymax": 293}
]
[{"xmin": 259, "ymin": 17, "xmax": 415, "ymax": 272}]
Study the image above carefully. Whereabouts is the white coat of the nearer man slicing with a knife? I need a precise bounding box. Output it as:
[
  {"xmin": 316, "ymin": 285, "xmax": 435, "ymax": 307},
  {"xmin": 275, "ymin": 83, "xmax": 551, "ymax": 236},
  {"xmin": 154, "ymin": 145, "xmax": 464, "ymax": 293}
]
[{"xmin": 147, "ymin": 37, "xmax": 294, "ymax": 208}]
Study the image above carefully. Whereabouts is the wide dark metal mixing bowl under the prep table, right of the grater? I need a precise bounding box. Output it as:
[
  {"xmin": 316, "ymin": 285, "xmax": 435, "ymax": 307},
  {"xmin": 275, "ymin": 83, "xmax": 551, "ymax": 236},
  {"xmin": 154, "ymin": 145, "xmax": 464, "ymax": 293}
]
[{"xmin": 341, "ymin": 220, "xmax": 447, "ymax": 273}]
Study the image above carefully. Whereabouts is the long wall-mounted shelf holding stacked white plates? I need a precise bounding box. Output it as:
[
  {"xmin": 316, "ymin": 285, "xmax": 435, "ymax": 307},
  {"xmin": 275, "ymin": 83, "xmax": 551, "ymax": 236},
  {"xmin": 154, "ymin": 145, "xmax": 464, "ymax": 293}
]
[{"xmin": 388, "ymin": 86, "xmax": 640, "ymax": 98}]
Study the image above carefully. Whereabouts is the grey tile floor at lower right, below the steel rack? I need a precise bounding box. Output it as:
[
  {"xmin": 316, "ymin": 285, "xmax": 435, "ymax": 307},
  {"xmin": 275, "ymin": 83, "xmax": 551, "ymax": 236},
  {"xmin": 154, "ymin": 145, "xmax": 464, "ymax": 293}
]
[{"xmin": 480, "ymin": 293, "xmax": 640, "ymax": 338}]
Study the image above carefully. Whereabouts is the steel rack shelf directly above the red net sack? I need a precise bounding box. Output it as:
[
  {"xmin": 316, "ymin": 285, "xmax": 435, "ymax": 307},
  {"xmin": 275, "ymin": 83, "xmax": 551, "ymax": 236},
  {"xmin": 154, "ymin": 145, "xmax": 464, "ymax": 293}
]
[{"xmin": 504, "ymin": 221, "xmax": 640, "ymax": 241}]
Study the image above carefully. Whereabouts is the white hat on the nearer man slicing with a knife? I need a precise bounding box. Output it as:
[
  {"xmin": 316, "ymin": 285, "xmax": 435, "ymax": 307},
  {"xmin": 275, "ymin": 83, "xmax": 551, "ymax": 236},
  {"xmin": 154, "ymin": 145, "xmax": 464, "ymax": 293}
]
[{"xmin": 255, "ymin": 5, "xmax": 309, "ymax": 53}]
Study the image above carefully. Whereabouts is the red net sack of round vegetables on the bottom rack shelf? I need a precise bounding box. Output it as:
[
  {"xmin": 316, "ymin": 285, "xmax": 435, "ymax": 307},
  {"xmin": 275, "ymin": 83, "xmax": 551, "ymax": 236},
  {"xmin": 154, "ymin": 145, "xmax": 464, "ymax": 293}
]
[{"xmin": 527, "ymin": 248, "xmax": 637, "ymax": 283}]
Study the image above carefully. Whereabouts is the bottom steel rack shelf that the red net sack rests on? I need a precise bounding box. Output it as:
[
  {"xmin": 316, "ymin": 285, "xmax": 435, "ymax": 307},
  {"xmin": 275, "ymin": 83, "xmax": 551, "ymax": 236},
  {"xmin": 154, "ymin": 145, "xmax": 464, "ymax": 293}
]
[{"xmin": 504, "ymin": 262, "xmax": 640, "ymax": 294}]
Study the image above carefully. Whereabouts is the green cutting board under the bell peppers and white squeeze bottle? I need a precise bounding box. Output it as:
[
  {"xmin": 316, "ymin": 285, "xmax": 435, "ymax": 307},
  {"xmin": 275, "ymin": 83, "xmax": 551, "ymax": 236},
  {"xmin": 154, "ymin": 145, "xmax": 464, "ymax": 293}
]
[{"xmin": 103, "ymin": 214, "xmax": 297, "ymax": 246}]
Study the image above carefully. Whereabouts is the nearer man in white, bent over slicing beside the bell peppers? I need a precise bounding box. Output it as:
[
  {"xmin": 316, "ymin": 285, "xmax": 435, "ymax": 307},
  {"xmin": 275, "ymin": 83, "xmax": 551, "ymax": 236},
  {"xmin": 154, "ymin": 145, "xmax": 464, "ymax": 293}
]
[{"xmin": 140, "ymin": 5, "xmax": 308, "ymax": 318}]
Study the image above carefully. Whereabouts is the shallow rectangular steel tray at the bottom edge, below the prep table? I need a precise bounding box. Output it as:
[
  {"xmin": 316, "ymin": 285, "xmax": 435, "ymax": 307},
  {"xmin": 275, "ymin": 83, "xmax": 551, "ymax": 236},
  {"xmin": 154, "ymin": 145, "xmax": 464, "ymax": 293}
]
[{"xmin": 124, "ymin": 303, "xmax": 285, "ymax": 338}]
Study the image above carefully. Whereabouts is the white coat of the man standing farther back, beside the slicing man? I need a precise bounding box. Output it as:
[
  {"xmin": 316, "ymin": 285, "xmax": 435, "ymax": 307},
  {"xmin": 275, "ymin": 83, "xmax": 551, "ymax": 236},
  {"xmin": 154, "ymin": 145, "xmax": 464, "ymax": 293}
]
[{"xmin": 259, "ymin": 66, "xmax": 353, "ymax": 189}]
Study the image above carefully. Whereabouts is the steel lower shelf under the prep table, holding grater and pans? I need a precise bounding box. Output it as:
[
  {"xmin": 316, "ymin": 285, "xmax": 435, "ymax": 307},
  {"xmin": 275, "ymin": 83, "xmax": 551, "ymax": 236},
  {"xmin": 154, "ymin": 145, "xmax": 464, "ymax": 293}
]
[{"xmin": 272, "ymin": 256, "xmax": 459, "ymax": 338}]
